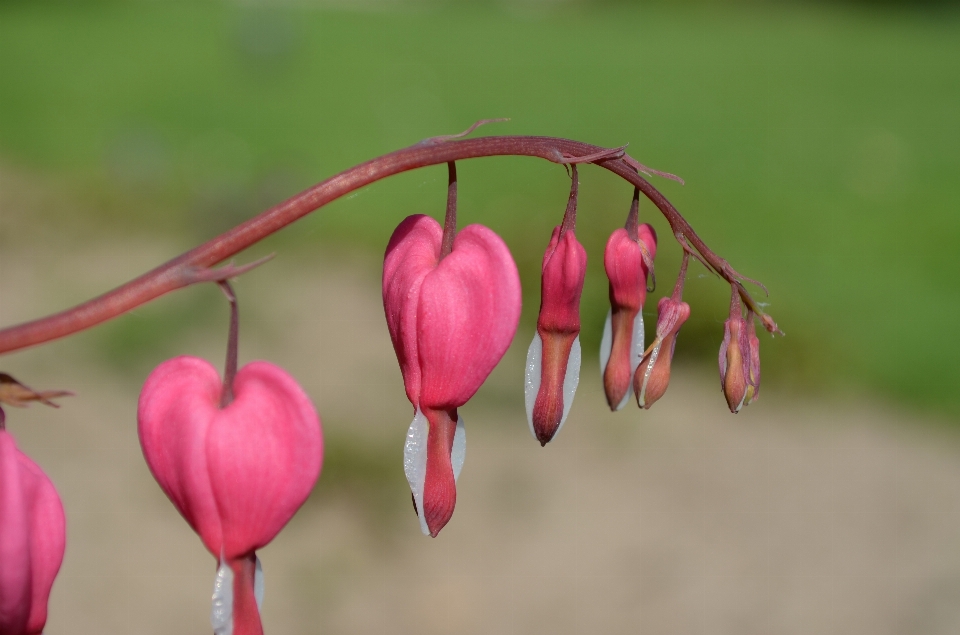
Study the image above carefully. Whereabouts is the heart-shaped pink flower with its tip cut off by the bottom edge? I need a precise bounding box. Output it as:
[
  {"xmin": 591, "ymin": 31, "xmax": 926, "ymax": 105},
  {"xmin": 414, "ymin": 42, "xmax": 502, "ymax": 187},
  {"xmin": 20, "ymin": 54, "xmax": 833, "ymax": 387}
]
[{"xmin": 137, "ymin": 356, "xmax": 323, "ymax": 635}]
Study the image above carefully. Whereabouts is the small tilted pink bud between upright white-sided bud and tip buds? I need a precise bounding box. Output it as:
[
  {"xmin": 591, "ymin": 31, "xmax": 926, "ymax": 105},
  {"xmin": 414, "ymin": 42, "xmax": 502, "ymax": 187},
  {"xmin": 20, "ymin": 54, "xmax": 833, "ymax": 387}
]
[{"xmin": 633, "ymin": 297, "xmax": 690, "ymax": 408}]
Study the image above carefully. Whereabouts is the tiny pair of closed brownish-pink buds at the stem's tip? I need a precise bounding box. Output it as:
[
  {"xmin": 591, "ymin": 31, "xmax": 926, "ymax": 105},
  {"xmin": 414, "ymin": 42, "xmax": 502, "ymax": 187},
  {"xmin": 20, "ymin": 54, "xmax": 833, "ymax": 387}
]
[{"xmin": 719, "ymin": 296, "xmax": 760, "ymax": 413}]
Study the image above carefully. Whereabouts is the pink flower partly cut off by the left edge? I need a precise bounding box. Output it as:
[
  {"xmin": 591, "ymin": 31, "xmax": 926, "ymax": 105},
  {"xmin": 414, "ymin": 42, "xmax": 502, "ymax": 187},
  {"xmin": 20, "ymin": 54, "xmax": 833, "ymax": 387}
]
[{"xmin": 0, "ymin": 428, "xmax": 66, "ymax": 635}]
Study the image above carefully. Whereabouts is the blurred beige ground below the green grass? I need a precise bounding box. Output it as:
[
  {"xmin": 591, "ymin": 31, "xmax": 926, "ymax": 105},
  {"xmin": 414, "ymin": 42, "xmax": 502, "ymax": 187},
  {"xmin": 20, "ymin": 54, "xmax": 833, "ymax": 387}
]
[{"xmin": 0, "ymin": 186, "xmax": 960, "ymax": 635}]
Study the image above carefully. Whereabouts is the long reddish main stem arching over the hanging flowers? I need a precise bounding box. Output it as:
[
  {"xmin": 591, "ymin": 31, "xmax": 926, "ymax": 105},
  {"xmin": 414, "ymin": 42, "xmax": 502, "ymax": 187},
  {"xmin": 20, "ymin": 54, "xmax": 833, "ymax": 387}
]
[{"xmin": 0, "ymin": 136, "xmax": 775, "ymax": 353}]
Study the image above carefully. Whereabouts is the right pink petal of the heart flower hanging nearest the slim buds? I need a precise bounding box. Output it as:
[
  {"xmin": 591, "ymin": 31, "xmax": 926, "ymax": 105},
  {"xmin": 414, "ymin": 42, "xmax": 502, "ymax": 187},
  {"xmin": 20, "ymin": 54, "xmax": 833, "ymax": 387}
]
[{"xmin": 417, "ymin": 225, "xmax": 521, "ymax": 413}]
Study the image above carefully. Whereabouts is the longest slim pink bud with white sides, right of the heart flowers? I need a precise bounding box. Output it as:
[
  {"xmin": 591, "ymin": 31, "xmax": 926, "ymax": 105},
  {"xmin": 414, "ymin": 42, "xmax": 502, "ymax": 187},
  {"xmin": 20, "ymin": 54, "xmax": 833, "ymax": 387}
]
[{"xmin": 525, "ymin": 226, "xmax": 587, "ymax": 445}]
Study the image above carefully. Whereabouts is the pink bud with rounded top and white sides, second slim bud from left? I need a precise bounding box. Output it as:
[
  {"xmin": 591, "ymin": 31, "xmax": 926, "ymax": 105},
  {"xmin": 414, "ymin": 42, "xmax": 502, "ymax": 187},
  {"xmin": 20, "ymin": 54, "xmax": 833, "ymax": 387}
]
[{"xmin": 600, "ymin": 223, "xmax": 657, "ymax": 410}]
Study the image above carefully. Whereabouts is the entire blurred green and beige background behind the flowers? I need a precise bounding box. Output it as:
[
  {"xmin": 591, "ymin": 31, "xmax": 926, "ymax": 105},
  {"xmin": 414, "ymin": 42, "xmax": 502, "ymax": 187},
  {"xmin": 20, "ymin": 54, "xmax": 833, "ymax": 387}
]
[{"xmin": 0, "ymin": 0, "xmax": 960, "ymax": 635}]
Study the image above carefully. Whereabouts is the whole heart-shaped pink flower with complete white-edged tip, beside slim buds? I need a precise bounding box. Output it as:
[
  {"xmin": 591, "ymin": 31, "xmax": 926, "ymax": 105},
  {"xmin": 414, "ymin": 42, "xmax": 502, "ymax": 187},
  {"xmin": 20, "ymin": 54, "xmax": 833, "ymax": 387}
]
[{"xmin": 383, "ymin": 215, "xmax": 520, "ymax": 536}]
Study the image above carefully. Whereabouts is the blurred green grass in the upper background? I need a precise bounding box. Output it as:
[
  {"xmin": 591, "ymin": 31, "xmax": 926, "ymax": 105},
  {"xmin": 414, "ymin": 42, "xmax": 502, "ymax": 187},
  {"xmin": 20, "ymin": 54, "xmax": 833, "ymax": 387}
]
[{"xmin": 0, "ymin": 2, "xmax": 960, "ymax": 415}]
